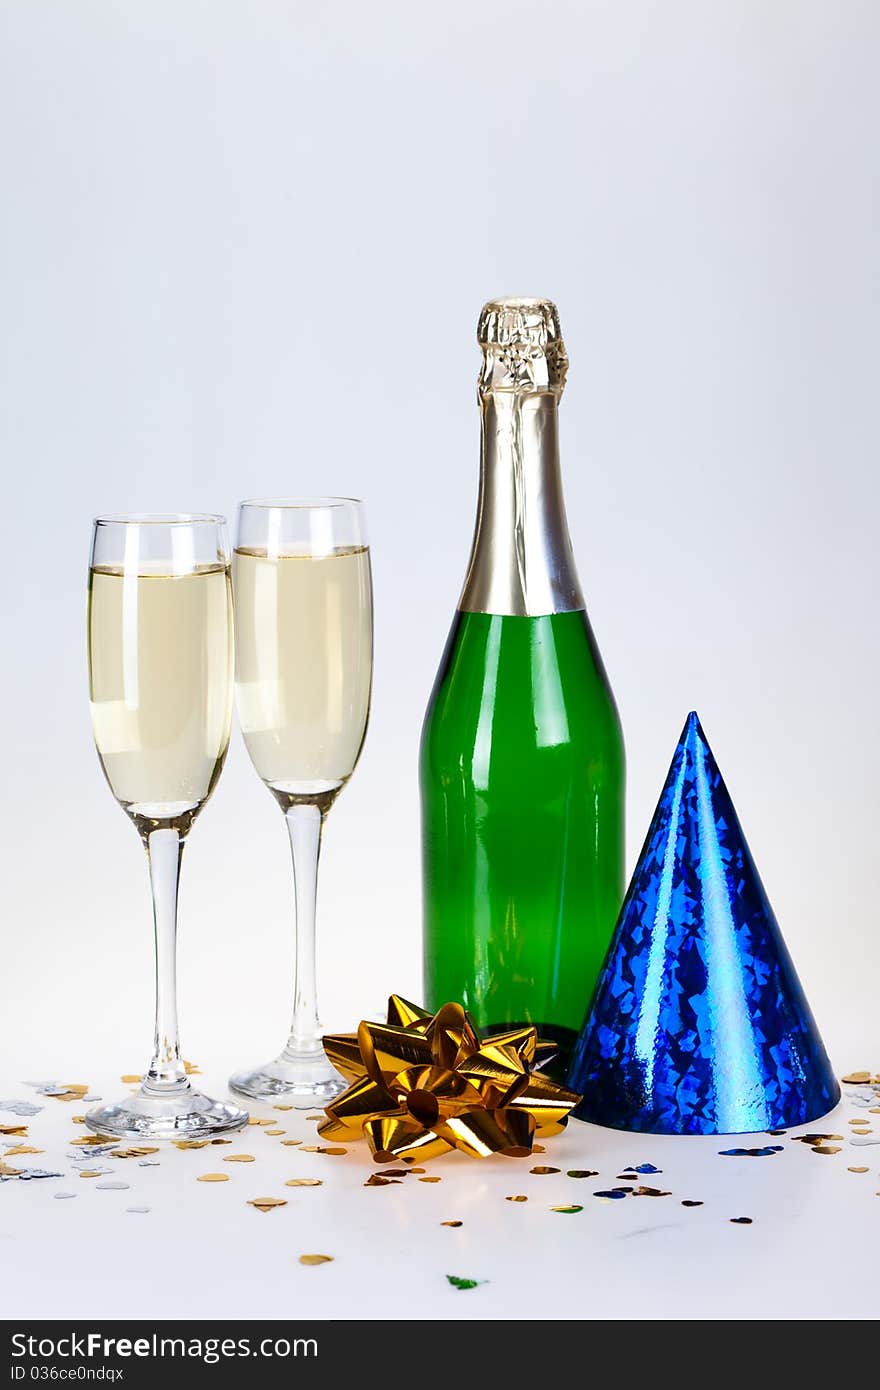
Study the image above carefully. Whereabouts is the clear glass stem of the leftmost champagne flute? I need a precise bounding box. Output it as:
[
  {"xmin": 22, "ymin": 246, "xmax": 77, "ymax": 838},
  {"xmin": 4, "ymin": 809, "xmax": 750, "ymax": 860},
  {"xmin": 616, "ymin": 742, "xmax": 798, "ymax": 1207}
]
[{"xmin": 143, "ymin": 830, "xmax": 189, "ymax": 1095}]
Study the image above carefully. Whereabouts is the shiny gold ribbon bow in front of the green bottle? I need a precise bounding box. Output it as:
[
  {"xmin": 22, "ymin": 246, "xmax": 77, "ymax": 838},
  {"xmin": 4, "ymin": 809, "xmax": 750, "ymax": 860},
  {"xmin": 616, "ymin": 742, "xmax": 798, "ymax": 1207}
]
[{"xmin": 318, "ymin": 994, "xmax": 580, "ymax": 1163}]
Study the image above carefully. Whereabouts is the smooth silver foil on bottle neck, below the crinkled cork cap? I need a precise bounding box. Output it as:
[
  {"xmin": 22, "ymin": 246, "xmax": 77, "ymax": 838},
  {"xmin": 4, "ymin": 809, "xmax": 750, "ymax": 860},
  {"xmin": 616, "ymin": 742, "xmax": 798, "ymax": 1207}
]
[{"xmin": 459, "ymin": 391, "xmax": 584, "ymax": 617}]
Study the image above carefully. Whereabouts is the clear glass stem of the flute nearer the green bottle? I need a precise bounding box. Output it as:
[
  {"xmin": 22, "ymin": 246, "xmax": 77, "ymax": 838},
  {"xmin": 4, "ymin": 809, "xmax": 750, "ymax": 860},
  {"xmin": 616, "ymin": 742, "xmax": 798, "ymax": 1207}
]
[{"xmin": 282, "ymin": 802, "xmax": 324, "ymax": 1062}]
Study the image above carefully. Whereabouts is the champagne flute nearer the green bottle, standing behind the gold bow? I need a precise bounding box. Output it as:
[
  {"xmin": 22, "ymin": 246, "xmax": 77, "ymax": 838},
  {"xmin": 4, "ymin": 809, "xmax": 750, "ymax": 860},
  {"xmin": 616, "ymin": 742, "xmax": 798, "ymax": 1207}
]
[{"xmin": 229, "ymin": 498, "xmax": 373, "ymax": 1109}]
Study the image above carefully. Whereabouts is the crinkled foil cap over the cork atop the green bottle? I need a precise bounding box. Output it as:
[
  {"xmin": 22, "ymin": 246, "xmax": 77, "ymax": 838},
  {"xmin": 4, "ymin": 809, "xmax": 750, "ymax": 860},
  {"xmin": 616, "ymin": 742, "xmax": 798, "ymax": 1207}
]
[{"xmin": 477, "ymin": 299, "xmax": 569, "ymax": 396}]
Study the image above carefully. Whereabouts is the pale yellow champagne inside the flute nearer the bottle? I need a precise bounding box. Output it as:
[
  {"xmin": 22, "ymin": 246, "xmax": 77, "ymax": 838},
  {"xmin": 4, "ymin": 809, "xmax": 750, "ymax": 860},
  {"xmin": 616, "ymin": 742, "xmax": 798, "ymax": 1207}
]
[{"xmin": 232, "ymin": 546, "xmax": 373, "ymax": 801}]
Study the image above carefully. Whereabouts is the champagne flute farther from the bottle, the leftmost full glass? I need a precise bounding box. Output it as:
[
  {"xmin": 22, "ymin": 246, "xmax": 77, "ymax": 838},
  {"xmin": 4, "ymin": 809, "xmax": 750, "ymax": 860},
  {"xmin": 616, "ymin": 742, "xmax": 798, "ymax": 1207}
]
[{"xmin": 86, "ymin": 514, "xmax": 247, "ymax": 1138}]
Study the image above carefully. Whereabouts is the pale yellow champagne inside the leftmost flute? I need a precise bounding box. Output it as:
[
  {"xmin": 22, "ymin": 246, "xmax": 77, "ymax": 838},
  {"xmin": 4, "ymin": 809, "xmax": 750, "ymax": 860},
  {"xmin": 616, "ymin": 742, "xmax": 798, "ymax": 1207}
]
[{"xmin": 89, "ymin": 566, "xmax": 232, "ymax": 824}]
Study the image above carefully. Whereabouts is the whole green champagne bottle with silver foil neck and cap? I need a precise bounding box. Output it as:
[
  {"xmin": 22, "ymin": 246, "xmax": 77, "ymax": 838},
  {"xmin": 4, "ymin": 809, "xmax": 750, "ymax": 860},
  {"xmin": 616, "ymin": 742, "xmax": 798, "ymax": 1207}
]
[{"xmin": 420, "ymin": 299, "xmax": 626, "ymax": 1044}]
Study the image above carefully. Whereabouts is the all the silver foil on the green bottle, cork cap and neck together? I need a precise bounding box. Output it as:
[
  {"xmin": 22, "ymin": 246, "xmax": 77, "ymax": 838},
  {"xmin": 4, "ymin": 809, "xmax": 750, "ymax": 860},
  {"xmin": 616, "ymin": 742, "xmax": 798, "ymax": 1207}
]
[{"xmin": 459, "ymin": 299, "xmax": 584, "ymax": 617}]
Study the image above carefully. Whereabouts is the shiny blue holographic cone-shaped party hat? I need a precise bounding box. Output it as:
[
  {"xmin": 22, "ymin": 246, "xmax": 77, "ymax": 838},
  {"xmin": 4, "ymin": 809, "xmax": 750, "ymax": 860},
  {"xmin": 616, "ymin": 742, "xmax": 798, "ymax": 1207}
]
[{"xmin": 567, "ymin": 714, "xmax": 840, "ymax": 1134}]
